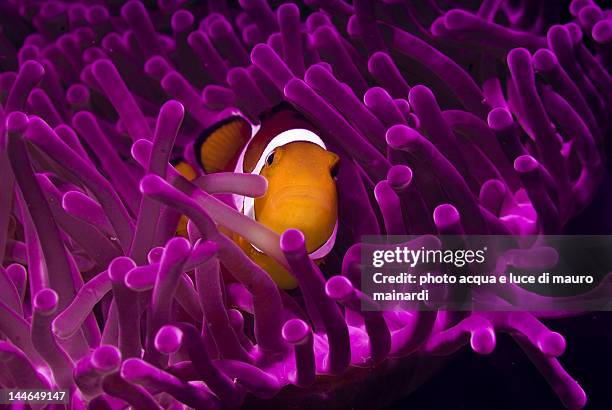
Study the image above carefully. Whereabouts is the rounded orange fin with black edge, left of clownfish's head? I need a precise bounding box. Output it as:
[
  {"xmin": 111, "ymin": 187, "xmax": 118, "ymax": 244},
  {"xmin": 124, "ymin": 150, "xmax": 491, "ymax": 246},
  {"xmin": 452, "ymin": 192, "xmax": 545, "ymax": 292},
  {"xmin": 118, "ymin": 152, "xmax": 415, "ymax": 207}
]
[{"xmin": 194, "ymin": 115, "xmax": 251, "ymax": 174}]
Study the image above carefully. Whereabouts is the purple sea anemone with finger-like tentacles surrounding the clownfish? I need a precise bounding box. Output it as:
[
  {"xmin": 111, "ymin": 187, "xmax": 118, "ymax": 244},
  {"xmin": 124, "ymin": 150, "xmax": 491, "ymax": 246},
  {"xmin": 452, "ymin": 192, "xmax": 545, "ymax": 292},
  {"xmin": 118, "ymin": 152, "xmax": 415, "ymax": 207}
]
[{"xmin": 0, "ymin": 0, "xmax": 612, "ymax": 409}]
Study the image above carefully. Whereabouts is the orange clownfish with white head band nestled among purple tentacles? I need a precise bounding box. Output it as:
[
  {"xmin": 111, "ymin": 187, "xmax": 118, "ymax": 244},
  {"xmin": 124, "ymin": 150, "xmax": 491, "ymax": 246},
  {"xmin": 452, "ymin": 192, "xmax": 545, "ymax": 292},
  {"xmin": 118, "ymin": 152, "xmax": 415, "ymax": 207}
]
[{"xmin": 177, "ymin": 105, "xmax": 339, "ymax": 289}]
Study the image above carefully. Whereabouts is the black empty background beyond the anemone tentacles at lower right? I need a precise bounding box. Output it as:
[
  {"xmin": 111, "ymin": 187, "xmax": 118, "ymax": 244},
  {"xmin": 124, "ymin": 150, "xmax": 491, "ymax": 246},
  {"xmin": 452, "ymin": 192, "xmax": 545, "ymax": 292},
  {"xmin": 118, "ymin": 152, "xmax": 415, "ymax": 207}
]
[{"xmin": 388, "ymin": 174, "xmax": 612, "ymax": 410}]
